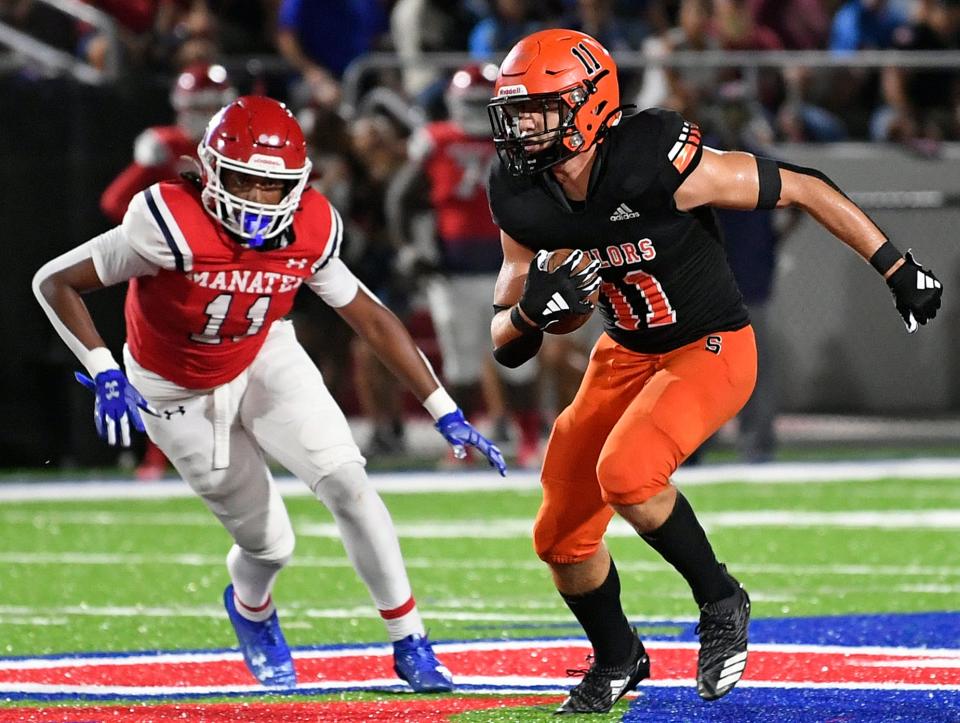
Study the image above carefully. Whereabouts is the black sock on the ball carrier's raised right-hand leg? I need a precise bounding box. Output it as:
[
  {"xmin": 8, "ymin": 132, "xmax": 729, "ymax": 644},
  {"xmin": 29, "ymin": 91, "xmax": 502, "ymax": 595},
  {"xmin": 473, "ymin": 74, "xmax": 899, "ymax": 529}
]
[{"xmin": 640, "ymin": 492, "xmax": 736, "ymax": 607}]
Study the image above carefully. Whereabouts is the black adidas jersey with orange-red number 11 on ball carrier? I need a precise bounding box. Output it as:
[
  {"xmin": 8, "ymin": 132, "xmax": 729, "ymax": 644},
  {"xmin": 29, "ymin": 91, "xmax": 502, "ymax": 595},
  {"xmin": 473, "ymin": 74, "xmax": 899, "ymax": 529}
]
[{"xmin": 488, "ymin": 109, "xmax": 749, "ymax": 353}]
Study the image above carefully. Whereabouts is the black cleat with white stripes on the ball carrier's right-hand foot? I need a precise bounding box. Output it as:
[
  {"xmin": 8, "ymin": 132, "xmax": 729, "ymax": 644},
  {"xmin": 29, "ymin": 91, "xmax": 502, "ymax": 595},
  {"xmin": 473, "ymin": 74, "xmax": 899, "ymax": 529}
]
[{"xmin": 697, "ymin": 568, "xmax": 750, "ymax": 700}]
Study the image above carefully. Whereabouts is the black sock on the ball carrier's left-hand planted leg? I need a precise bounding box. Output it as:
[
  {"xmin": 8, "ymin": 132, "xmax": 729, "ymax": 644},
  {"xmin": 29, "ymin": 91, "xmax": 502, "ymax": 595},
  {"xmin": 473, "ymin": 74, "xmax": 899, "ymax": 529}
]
[{"xmin": 560, "ymin": 558, "xmax": 636, "ymax": 666}]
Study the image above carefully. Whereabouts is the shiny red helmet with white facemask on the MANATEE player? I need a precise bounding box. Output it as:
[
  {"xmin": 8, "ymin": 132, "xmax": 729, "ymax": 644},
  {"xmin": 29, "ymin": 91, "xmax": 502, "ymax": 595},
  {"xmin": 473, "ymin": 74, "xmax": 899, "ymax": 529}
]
[{"xmin": 197, "ymin": 95, "xmax": 311, "ymax": 247}]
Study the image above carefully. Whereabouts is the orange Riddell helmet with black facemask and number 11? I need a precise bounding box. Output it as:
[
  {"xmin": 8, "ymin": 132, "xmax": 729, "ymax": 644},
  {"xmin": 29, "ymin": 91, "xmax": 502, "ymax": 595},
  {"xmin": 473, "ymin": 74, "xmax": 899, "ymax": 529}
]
[{"xmin": 487, "ymin": 30, "xmax": 621, "ymax": 176}]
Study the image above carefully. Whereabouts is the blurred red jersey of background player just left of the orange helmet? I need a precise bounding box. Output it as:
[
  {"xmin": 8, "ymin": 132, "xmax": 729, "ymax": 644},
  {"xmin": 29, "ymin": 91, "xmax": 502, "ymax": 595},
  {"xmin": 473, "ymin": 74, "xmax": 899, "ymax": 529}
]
[{"xmin": 410, "ymin": 121, "xmax": 500, "ymax": 243}]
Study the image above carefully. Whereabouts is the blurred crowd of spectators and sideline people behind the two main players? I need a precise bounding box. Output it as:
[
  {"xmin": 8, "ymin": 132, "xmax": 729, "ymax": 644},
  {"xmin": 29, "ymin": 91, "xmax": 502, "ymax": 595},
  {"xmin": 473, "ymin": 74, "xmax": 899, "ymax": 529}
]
[{"xmin": 0, "ymin": 0, "xmax": 960, "ymax": 465}]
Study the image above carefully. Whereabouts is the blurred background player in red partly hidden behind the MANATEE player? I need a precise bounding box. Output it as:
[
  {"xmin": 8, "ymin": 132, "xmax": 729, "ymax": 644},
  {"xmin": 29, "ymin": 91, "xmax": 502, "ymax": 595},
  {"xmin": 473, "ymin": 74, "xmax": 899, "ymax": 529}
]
[{"xmin": 100, "ymin": 63, "xmax": 237, "ymax": 480}]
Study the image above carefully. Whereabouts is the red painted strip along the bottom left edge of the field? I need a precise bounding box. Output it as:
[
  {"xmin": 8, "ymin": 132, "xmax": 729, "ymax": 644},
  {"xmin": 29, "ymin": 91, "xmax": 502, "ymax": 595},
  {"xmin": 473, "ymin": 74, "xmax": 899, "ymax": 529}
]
[{"xmin": 0, "ymin": 696, "xmax": 561, "ymax": 723}]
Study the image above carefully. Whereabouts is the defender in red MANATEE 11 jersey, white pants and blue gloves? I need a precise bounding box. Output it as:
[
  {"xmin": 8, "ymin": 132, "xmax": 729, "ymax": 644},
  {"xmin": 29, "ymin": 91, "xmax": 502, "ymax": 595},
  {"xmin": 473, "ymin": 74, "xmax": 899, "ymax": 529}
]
[{"xmin": 34, "ymin": 96, "xmax": 504, "ymax": 692}]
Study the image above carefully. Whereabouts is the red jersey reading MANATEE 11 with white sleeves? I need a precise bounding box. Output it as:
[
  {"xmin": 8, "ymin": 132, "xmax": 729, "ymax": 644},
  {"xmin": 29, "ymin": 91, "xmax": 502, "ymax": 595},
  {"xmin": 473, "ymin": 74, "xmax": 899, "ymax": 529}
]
[{"xmin": 123, "ymin": 182, "xmax": 343, "ymax": 389}]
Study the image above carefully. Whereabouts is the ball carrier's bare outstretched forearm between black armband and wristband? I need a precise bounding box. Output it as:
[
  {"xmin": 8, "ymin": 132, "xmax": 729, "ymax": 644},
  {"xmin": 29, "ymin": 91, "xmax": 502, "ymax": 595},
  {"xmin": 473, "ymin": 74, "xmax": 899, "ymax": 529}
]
[{"xmin": 778, "ymin": 169, "xmax": 887, "ymax": 260}]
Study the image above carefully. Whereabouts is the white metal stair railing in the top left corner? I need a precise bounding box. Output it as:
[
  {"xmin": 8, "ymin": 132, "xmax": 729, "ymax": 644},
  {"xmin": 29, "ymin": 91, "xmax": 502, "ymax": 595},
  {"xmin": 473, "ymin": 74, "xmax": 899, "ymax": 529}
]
[{"xmin": 0, "ymin": 0, "xmax": 120, "ymax": 85}]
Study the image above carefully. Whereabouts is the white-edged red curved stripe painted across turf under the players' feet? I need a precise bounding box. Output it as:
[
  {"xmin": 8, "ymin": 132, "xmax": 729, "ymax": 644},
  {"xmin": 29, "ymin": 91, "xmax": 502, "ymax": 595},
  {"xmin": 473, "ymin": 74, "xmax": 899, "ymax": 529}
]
[{"xmin": 0, "ymin": 642, "xmax": 960, "ymax": 695}]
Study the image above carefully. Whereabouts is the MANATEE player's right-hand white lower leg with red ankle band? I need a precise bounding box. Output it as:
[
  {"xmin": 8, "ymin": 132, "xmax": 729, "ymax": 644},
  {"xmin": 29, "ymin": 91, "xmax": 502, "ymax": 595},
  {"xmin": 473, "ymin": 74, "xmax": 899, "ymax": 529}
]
[{"xmin": 314, "ymin": 464, "xmax": 424, "ymax": 640}]
